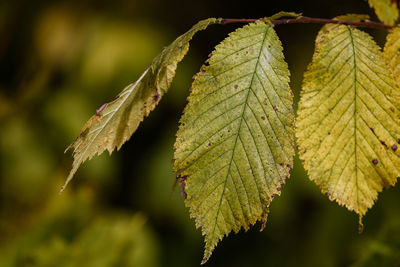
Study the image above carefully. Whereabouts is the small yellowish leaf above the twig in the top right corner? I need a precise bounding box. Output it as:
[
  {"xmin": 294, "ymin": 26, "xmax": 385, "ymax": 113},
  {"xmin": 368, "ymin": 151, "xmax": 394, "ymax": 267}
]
[{"xmin": 368, "ymin": 0, "xmax": 399, "ymax": 25}]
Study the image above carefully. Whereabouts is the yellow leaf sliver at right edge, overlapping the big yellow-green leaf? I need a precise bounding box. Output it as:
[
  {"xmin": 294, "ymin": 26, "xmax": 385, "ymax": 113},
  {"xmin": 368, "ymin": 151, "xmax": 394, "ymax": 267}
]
[{"xmin": 383, "ymin": 27, "xmax": 400, "ymax": 86}]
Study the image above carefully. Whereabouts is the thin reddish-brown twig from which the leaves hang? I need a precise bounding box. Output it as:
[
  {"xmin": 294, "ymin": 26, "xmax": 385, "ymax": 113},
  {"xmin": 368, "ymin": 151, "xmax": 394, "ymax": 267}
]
[{"xmin": 221, "ymin": 16, "xmax": 396, "ymax": 29}]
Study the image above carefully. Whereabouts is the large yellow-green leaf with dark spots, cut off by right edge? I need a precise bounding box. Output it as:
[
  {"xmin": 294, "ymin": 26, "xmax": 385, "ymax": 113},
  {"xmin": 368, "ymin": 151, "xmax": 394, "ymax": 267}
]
[{"xmin": 296, "ymin": 19, "xmax": 400, "ymax": 226}]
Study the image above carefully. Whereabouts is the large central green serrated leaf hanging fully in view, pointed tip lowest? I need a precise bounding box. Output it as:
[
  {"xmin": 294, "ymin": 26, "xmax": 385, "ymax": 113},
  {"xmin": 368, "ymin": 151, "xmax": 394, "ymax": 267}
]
[{"xmin": 174, "ymin": 22, "xmax": 294, "ymax": 263}]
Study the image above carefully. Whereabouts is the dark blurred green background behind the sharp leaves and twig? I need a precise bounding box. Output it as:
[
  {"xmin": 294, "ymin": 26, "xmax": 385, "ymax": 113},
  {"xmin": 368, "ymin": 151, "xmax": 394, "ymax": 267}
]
[{"xmin": 0, "ymin": 0, "xmax": 400, "ymax": 267}]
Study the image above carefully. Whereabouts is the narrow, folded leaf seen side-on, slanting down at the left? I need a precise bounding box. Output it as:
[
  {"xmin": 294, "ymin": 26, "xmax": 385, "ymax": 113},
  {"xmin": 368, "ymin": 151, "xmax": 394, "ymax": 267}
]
[{"xmin": 61, "ymin": 18, "xmax": 221, "ymax": 191}]
